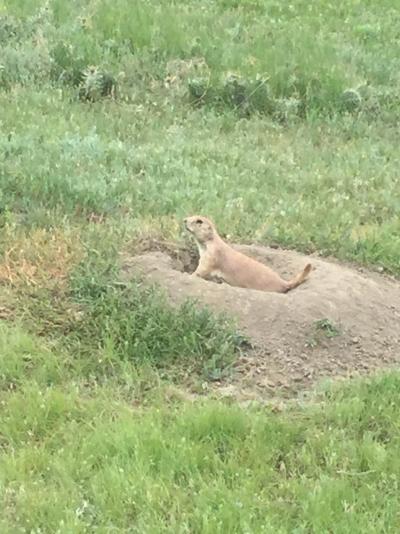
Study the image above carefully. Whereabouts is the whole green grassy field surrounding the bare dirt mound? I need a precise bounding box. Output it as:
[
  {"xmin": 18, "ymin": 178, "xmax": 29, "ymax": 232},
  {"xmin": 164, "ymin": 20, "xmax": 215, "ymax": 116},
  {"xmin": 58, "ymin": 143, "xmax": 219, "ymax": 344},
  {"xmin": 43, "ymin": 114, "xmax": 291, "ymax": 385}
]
[{"xmin": 0, "ymin": 0, "xmax": 400, "ymax": 534}]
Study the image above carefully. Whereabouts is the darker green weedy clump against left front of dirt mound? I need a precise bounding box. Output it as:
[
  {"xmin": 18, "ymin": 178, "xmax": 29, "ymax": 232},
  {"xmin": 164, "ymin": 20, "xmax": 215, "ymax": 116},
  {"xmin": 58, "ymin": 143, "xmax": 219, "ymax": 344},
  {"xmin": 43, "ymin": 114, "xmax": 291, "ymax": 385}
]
[{"xmin": 71, "ymin": 249, "xmax": 244, "ymax": 380}]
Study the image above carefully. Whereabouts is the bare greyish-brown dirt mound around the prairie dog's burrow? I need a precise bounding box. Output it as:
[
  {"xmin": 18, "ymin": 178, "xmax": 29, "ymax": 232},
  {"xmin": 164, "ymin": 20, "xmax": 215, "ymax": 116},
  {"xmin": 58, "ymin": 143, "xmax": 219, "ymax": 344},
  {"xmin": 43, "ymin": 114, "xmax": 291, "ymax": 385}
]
[{"xmin": 123, "ymin": 244, "xmax": 400, "ymax": 397}]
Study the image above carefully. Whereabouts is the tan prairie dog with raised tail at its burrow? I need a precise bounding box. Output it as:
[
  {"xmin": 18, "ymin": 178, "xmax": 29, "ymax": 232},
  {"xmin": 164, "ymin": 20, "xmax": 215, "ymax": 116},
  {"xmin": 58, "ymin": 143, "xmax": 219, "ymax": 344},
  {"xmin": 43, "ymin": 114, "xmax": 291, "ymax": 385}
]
[{"xmin": 184, "ymin": 215, "xmax": 311, "ymax": 293}]
